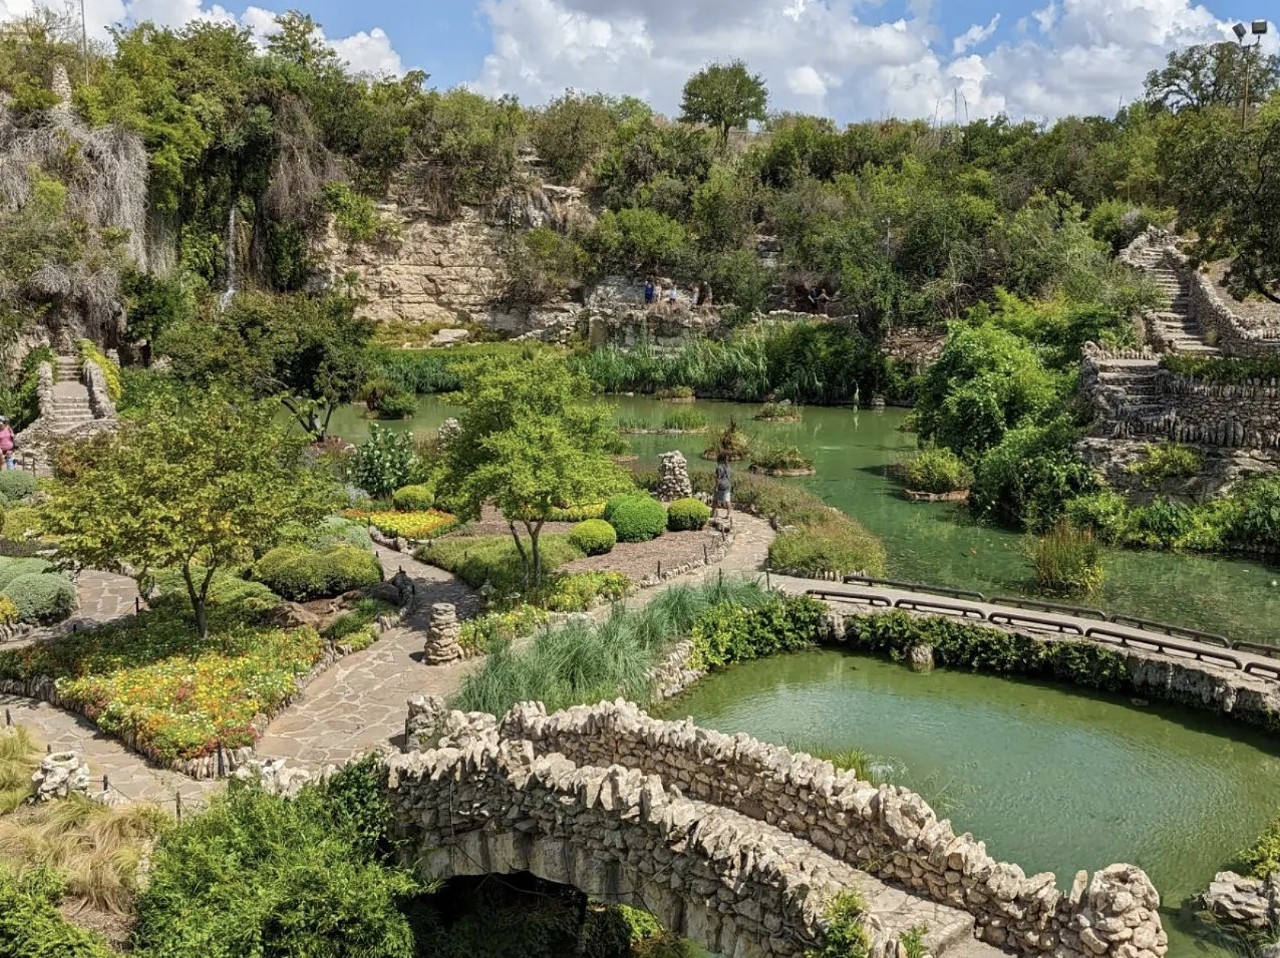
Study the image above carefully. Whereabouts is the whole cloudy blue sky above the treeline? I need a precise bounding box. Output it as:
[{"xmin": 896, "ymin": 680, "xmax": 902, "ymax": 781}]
[{"xmin": 0, "ymin": 0, "xmax": 1280, "ymax": 123}]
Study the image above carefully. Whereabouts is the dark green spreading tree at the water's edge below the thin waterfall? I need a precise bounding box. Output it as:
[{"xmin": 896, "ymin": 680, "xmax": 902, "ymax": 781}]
[{"xmin": 159, "ymin": 292, "xmax": 374, "ymax": 441}]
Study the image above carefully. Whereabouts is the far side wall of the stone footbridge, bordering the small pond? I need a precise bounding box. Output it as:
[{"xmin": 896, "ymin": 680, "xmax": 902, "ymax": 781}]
[{"xmin": 500, "ymin": 701, "xmax": 1167, "ymax": 958}]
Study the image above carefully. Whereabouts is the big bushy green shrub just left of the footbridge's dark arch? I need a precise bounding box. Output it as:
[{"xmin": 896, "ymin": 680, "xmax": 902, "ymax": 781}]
[{"xmin": 134, "ymin": 761, "xmax": 426, "ymax": 958}]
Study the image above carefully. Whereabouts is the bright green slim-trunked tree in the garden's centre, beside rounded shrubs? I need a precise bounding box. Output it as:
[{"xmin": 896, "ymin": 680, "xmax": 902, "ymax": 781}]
[{"xmin": 442, "ymin": 353, "xmax": 627, "ymax": 585}]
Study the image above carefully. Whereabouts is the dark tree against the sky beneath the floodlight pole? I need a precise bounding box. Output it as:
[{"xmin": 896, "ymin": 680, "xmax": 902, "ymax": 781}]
[{"xmin": 1147, "ymin": 42, "xmax": 1280, "ymax": 110}]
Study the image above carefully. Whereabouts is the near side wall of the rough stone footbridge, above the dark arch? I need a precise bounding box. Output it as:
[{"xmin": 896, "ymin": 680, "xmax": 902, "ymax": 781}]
[{"xmin": 383, "ymin": 730, "xmax": 860, "ymax": 958}]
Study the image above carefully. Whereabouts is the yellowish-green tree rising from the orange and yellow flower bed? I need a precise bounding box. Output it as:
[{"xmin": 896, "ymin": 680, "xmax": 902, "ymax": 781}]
[{"xmin": 44, "ymin": 389, "xmax": 332, "ymax": 638}]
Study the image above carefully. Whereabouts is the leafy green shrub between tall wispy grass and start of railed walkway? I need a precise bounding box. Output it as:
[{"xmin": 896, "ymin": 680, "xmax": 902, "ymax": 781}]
[{"xmin": 689, "ymin": 596, "xmax": 827, "ymax": 671}]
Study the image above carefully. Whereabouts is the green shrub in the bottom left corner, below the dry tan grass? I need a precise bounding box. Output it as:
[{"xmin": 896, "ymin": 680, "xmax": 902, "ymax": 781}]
[{"xmin": 0, "ymin": 870, "xmax": 115, "ymax": 958}]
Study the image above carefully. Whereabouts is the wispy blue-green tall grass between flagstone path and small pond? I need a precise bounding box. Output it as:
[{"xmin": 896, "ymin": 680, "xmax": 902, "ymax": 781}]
[{"xmin": 453, "ymin": 579, "xmax": 768, "ymax": 715}]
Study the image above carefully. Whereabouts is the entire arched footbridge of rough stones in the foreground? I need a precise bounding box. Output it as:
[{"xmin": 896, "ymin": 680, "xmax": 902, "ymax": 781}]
[{"xmin": 384, "ymin": 699, "xmax": 1166, "ymax": 958}]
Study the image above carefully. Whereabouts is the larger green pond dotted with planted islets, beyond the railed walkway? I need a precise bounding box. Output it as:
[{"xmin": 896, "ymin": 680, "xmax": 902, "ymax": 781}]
[{"xmin": 325, "ymin": 397, "xmax": 1280, "ymax": 642}]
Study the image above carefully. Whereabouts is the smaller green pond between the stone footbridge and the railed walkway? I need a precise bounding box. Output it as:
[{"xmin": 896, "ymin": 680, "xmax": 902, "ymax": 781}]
[{"xmin": 664, "ymin": 651, "xmax": 1280, "ymax": 958}]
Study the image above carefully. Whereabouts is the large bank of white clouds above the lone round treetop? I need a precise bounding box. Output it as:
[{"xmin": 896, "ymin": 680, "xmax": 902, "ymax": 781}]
[{"xmin": 474, "ymin": 0, "xmax": 1274, "ymax": 122}]
